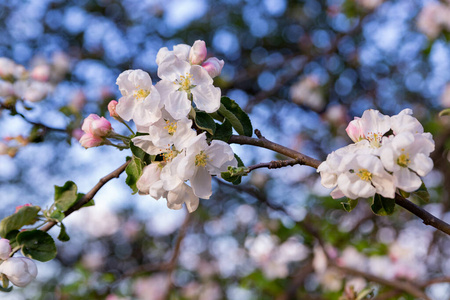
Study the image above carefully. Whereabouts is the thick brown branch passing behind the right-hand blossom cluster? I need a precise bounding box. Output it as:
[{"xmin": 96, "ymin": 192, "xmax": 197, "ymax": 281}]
[{"xmin": 228, "ymin": 129, "xmax": 450, "ymax": 235}]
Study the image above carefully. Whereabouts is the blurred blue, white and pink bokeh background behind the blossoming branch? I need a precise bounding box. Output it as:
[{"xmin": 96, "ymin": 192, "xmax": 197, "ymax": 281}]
[{"xmin": 0, "ymin": 0, "xmax": 450, "ymax": 300}]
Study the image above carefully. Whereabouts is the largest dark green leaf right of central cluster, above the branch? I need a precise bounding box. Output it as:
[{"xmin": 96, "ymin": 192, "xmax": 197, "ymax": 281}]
[{"xmin": 218, "ymin": 97, "xmax": 253, "ymax": 136}]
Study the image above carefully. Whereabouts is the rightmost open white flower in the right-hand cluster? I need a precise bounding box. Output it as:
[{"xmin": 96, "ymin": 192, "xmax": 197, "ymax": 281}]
[{"xmin": 380, "ymin": 132, "xmax": 434, "ymax": 192}]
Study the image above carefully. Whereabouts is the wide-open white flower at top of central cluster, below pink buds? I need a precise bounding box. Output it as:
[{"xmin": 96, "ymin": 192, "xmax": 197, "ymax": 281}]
[{"xmin": 156, "ymin": 59, "xmax": 221, "ymax": 120}]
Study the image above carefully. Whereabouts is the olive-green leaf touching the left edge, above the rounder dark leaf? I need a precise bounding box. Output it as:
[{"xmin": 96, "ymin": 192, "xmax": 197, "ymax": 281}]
[{"xmin": 0, "ymin": 206, "xmax": 41, "ymax": 237}]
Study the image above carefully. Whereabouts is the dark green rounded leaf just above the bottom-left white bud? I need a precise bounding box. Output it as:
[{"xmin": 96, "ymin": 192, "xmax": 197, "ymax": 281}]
[{"xmin": 17, "ymin": 230, "xmax": 57, "ymax": 262}]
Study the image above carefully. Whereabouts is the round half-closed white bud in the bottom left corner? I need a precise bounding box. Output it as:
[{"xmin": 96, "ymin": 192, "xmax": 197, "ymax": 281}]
[{"xmin": 0, "ymin": 257, "xmax": 37, "ymax": 287}]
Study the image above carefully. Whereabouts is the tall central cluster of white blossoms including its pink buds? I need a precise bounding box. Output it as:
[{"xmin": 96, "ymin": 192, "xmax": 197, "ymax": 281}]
[{"xmin": 89, "ymin": 41, "xmax": 237, "ymax": 212}]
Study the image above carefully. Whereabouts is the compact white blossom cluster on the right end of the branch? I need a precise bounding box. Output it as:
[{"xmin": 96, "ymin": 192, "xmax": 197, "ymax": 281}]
[{"xmin": 317, "ymin": 109, "xmax": 434, "ymax": 199}]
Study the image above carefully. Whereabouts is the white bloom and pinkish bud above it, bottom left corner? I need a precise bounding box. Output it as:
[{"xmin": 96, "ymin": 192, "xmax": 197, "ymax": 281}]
[{"xmin": 0, "ymin": 239, "xmax": 37, "ymax": 287}]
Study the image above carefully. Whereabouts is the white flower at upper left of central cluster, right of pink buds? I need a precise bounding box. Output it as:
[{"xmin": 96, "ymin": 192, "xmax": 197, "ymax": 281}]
[{"xmin": 116, "ymin": 70, "xmax": 163, "ymax": 126}]
